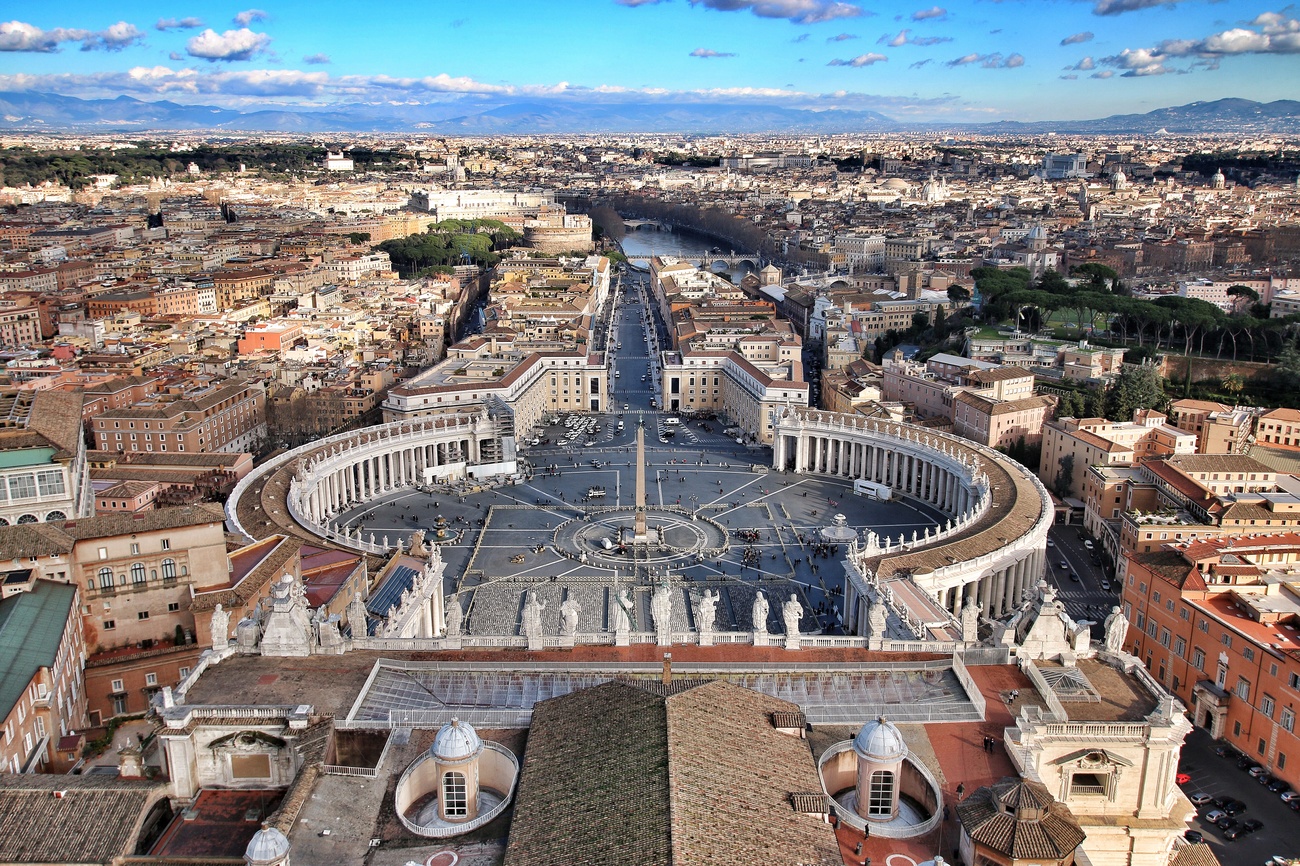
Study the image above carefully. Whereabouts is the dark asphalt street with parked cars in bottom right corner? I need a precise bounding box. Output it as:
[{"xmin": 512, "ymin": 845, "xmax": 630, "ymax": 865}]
[{"xmin": 1178, "ymin": 728, "xmax": 1300, "ymax": 863}]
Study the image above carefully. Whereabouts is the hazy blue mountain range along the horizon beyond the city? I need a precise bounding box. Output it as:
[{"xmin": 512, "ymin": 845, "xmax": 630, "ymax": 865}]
[{"xmin": 0, "ymin": 91, "xmax": 1300, "ymax": 135}]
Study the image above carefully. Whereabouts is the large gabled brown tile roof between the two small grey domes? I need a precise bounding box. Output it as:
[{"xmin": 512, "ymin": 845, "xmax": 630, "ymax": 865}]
[{"xmin": 506, "ymin": 680, "xmax": 841, "ymax": 866}]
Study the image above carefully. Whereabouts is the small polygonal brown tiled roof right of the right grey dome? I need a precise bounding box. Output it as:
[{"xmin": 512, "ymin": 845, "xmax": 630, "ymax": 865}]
[{"xmin": 957, "ymin": 779, "xmax": 1084, "ymax": 859}]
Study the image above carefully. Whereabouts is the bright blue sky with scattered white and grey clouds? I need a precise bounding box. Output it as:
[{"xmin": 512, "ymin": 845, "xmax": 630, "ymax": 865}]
[{"xmin": 0, "ymin": 0, "xmax": 1300, "ymax": 122}]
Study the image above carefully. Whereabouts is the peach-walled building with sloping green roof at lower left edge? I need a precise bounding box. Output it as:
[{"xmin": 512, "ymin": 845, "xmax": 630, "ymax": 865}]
[{"xmin": 0, "ymin": 579, "xmax": 88, "ymax": 772}]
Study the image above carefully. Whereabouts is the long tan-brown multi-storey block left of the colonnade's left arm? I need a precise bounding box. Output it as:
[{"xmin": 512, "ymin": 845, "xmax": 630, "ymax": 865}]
[{"xmin": 94, "ymin": 381, "xmax": 267, "ymax": 454}]
